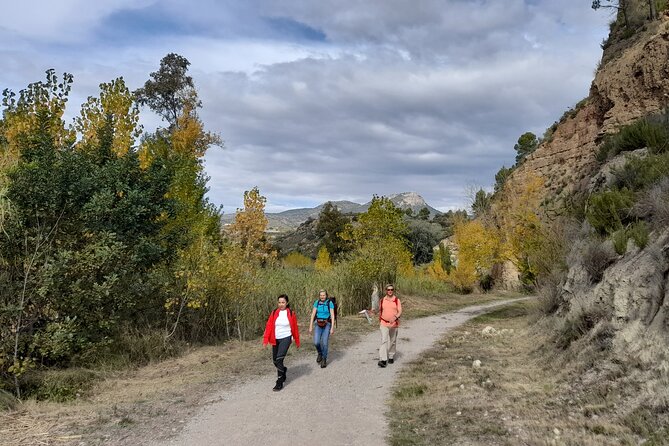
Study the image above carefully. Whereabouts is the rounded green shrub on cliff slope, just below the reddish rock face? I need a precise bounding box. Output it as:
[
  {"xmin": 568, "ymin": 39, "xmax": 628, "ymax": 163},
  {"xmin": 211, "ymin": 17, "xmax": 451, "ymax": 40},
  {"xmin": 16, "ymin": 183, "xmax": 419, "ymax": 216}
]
[{"xmin": 586, "ymin": 188, "xmax": 634, "ymax": 235}]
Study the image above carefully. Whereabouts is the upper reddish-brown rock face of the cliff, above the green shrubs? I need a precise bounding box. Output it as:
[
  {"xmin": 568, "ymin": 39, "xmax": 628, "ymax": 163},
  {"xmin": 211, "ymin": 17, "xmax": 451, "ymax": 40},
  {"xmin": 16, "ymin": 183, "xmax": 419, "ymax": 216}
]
[{"xmin": 509, "ymin": 16, "xmax": 669, "ymax": 199}]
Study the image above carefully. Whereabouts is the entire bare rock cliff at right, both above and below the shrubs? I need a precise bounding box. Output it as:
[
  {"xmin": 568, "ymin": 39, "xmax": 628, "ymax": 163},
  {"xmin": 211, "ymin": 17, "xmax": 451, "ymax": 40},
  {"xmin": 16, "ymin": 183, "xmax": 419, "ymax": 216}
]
[{"xmin": 509, "ymin": 15, "xmax": 669, "ymax": 415}]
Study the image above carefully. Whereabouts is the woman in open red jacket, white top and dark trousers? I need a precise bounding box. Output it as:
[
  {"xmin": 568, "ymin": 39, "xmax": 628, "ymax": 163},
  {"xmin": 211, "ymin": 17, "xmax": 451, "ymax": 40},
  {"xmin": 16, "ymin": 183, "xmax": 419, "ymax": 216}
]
[{"xmin": 262, "ymin": 294, "xmax": 300, "ymax": 392}]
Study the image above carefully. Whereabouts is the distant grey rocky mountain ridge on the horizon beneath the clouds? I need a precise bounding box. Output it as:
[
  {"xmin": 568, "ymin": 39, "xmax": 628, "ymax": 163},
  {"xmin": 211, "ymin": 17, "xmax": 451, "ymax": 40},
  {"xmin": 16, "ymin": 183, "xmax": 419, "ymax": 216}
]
[{"xmin": 223, "ymin": 192, "xmax": 441, "ymax": 231}]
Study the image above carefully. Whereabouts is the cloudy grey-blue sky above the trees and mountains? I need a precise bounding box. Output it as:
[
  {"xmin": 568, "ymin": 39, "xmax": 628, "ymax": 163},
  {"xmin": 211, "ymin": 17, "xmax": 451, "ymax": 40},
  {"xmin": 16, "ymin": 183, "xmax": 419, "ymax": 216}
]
[{"xmin": 0, "ymin": 0, "xmax": 610, "ymax": 213}]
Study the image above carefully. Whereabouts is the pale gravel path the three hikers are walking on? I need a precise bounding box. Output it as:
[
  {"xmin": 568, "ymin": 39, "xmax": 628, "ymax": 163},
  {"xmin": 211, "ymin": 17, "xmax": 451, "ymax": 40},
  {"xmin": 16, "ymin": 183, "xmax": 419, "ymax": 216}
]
[{"xmin": 154, "ymin": 299, "xmax": 519, "ymax": 446}]
